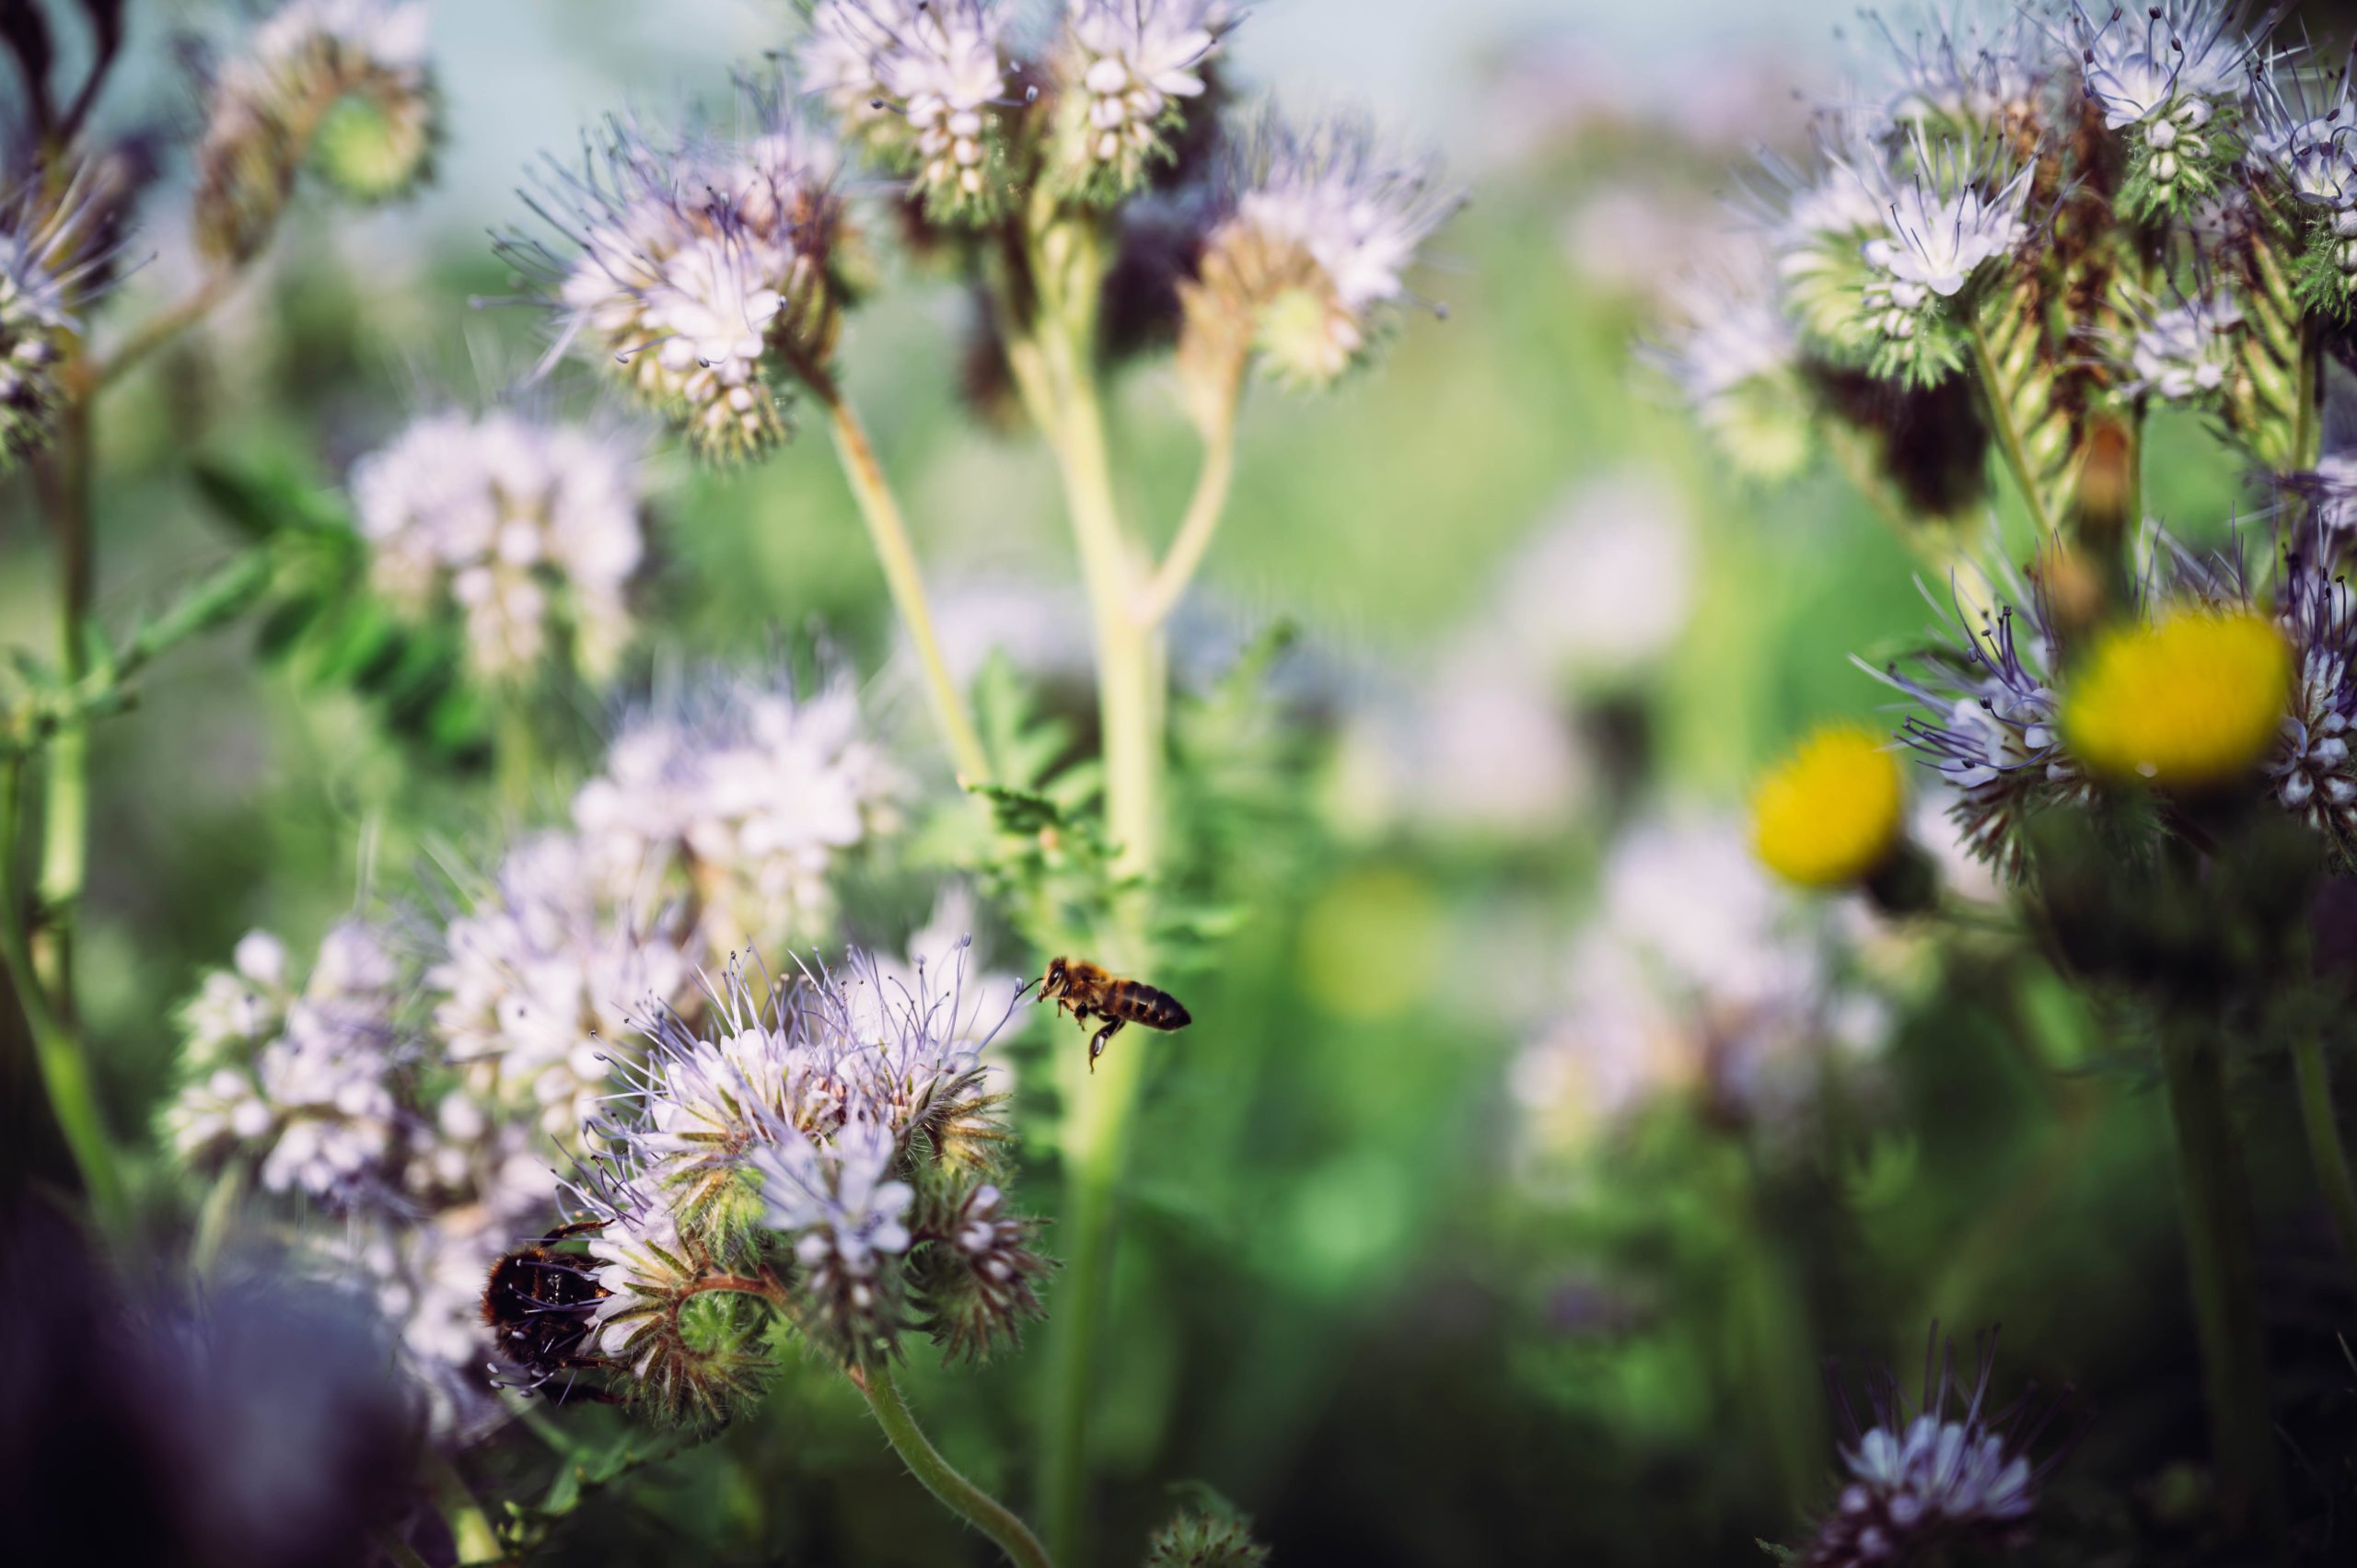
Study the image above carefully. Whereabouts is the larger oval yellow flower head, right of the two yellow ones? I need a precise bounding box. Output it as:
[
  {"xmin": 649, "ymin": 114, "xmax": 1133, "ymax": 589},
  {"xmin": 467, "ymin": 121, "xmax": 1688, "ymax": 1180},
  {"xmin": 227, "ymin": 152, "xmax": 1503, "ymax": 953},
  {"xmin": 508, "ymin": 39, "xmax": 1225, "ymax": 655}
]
[{"xmin": 2062, "ymin": 609, "xmax": 2291, "ymax": 790}]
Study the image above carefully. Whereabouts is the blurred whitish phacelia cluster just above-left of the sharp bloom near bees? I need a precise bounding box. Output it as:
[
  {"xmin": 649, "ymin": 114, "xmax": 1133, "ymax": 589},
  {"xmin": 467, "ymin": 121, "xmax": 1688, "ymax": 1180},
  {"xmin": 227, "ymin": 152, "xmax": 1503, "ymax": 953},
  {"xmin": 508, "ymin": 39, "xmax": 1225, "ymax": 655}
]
[{"xmin": 426, "ymin": 832, "xmax": 693, "ymax": 1148}]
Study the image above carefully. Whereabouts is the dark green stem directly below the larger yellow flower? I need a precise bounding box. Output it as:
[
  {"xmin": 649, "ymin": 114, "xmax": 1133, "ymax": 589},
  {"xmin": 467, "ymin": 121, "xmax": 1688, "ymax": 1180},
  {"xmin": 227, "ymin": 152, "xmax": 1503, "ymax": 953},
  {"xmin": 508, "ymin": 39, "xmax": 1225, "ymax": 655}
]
[{"xmin": 2162, "ymin": 1026, "xmax": 2286, "ymax": 1544}]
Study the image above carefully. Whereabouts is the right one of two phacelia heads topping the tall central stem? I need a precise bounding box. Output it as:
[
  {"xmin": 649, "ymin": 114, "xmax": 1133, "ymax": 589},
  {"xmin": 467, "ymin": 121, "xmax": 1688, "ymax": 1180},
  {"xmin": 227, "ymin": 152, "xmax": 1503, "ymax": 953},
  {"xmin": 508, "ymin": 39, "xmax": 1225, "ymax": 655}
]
[{"xmin": 1056, "ymin": 0, "xmax": 1237, "ymax": 201}]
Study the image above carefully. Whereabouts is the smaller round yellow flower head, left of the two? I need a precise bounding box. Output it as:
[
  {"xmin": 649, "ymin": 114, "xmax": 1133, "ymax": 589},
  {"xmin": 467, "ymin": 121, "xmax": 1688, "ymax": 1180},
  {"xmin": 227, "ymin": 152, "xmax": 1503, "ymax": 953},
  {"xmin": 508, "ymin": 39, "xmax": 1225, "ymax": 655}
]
[{"xmin": 1751, "ymin": 724, "xmax": 1907, "ymax": 887}]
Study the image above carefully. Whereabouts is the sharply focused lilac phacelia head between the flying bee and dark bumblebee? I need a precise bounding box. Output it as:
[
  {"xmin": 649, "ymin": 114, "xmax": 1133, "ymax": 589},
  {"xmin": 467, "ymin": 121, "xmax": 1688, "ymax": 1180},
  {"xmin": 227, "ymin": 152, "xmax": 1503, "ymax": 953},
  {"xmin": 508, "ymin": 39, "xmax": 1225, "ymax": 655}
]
[{"xmin": 540, "ymin": 943, "xmax": 1044, "ymax": 1417}]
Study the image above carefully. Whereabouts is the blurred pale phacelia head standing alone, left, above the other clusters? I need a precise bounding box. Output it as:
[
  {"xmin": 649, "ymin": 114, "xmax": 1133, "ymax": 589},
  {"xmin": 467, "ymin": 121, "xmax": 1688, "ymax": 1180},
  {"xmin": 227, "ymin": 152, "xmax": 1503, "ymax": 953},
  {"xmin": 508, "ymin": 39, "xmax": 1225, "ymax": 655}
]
[{"xmin": 351, "ymin": 412, "xmax": 645, "ymax": 681}]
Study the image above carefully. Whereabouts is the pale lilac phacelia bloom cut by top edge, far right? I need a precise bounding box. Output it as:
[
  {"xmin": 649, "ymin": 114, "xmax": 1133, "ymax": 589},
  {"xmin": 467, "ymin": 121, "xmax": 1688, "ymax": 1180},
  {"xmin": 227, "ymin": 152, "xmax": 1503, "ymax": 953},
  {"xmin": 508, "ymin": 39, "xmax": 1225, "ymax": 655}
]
[{"xmin": 2065, "ymin": 0, "xmax": 2256, "ymax": 212}]
